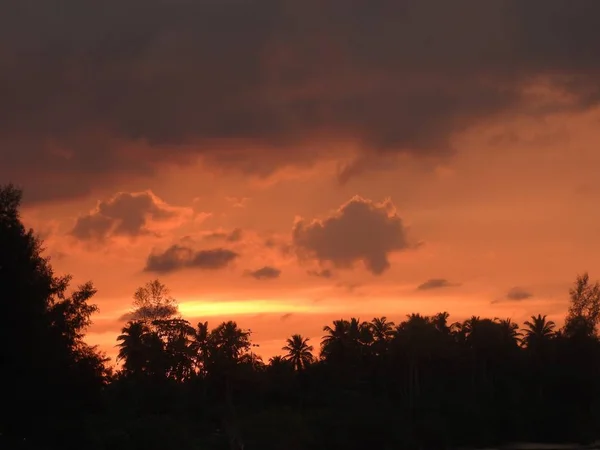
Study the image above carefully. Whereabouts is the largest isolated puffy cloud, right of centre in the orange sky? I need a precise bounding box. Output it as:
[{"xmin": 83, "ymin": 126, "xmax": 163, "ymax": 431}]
[{"xmin": 292, "ymin": 196, "xmax": 411, "ymax": 275}]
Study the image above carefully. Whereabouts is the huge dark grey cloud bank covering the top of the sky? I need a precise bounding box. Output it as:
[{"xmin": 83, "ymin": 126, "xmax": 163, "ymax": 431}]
[{"xmin": 0, "ymin": 0, "xmax": 600, "ymax": 200}]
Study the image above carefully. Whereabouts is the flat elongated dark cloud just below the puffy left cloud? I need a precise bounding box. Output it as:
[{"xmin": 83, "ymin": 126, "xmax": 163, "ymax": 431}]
[{"xmin": 144, "ymin": 245, "xmax": 239, "ymax": 274}]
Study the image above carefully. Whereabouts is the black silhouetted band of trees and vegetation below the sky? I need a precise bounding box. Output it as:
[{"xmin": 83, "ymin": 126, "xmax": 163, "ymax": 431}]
[{"xmin": 0, "ymin": 186, "xmax": 600, "ymax": 450}]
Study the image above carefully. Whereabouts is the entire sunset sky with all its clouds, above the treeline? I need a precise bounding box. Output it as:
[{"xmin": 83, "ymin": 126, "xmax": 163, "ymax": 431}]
[{"xmin": 0, "ymin": 0, "xmax": 600, "ymax": 359}]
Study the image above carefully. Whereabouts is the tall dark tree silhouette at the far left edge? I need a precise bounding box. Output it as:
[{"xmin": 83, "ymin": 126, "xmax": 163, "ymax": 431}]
[{"xmin": 0, "ymin": 184, "xmax": 109, "ymax": 448}]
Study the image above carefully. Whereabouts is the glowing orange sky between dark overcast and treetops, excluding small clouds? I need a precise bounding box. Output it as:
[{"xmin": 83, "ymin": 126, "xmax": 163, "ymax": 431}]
[{"xmin": 16, "ymin": 110, "xmax": 600, "ymax": 364}]
